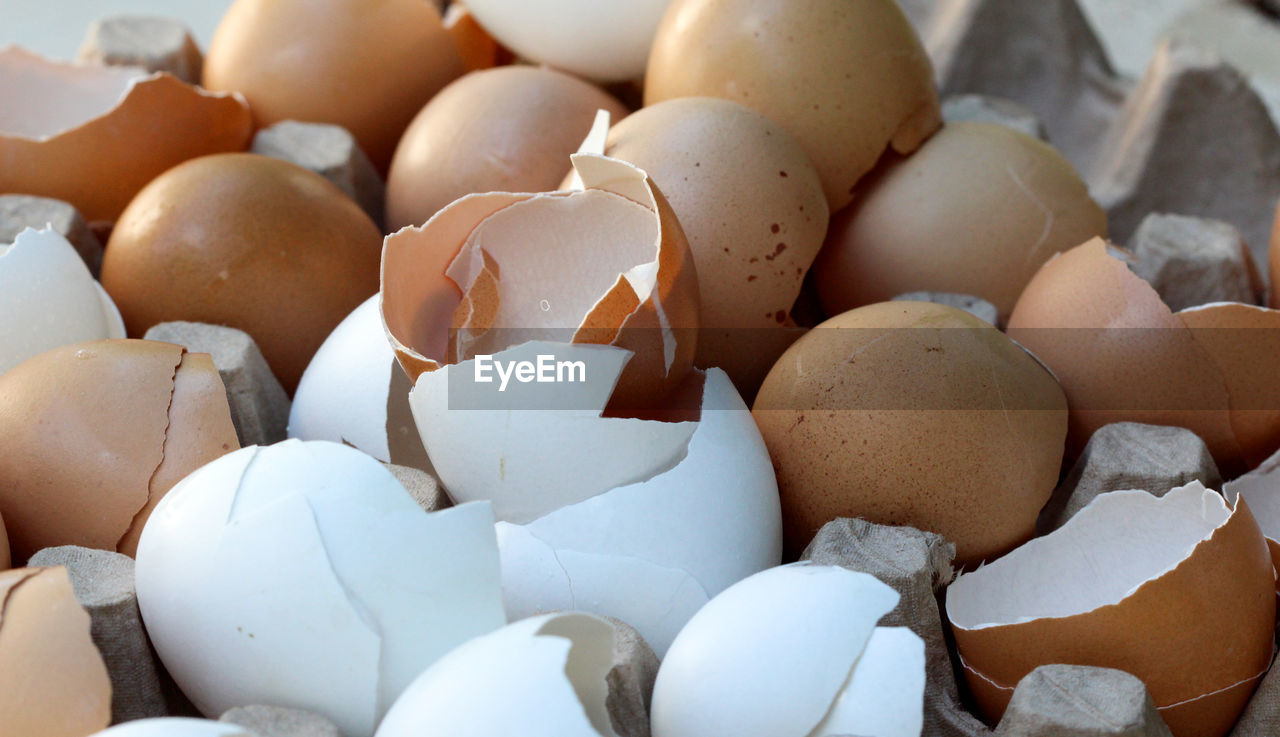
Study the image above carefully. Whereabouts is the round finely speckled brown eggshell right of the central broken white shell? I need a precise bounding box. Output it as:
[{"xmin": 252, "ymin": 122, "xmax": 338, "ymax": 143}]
[{"xmin": 751, "ymin": 302, "xmax": 1068, "ymax": 564}]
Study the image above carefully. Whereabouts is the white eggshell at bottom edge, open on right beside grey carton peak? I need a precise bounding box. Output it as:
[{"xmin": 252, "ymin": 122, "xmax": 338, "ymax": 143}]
[{"xmin": 376, "ymin": 613, "xmax": 617, "ymax": 737}]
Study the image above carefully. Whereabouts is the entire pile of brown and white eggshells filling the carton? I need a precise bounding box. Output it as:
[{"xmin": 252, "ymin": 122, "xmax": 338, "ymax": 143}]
[{"xmin": 0, "ymin": 0, "xmax": 1280, "ymax": 737}]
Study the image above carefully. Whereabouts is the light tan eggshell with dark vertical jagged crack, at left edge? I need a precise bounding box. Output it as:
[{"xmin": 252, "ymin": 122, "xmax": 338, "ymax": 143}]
[{"xmin": 0, "ymin": 340, "xmax": 239, "ymax": 560}]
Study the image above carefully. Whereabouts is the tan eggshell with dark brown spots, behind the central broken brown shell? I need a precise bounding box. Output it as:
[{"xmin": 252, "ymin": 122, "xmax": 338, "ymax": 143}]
[{"xmin": 604, "ymin": 97, "xmax": 828, "ymax": 397}]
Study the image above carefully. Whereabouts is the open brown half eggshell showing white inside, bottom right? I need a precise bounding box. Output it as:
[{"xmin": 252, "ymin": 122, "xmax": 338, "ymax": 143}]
[{"xmin": 946, "ymin": 482, "xmax": 1275, "ymax": 737}]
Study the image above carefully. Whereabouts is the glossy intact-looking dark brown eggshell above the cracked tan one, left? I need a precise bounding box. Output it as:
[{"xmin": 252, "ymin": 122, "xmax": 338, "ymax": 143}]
[{"xmin": 102, "ymin": 154, "xmax": 381, "ymax": 393}]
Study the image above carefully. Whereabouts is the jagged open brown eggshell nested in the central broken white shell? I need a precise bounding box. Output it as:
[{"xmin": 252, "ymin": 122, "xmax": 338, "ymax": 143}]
[{"xmin": 381, "ymin": 155, "xmax": 699, "ymax": 407}]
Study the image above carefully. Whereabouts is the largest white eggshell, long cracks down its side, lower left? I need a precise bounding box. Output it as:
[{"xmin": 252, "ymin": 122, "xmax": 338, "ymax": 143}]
[{"xmin": 137, "ymin": 440, "xmax": 504, "ymax": 737}]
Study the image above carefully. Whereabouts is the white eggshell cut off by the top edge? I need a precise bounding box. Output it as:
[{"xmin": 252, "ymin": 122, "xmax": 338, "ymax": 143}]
[{"xmin": 467, "ymin": 0, "xmax": 671, "ymax": 82}]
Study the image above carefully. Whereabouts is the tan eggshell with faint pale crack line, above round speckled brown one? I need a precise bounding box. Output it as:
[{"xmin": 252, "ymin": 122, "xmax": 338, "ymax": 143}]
[{"xmin": 814, "ymin": 123, "xmax": 1107, "ymax": 319}]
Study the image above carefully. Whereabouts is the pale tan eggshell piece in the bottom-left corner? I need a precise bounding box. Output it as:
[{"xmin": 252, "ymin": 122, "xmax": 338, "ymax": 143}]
[{"xmin": 0, "ymin": 567, "xmax": 111, "ymax": 737}]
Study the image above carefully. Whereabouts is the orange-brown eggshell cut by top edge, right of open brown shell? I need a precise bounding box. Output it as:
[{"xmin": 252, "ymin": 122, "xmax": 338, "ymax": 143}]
[{"xmin": 204, "ymin": 0, "xmax": 463, "ymax": 171}]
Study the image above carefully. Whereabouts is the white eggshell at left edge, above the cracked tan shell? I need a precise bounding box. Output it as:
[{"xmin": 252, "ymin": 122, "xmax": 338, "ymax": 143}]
[{"xmin": 0, "ymin": 228, "xmax": 124, "ymax": 374}]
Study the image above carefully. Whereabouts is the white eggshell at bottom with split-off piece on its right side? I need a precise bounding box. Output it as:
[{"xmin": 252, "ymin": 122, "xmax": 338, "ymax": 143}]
[{"xmin": 652, "ymin": 563, "xmax": 924, "ymax": 737}]
